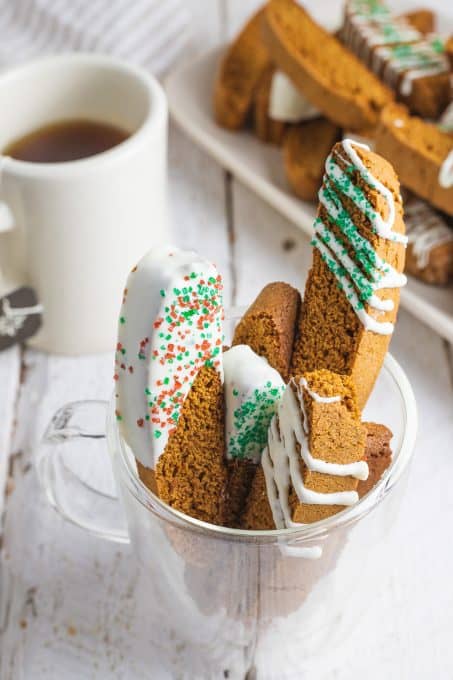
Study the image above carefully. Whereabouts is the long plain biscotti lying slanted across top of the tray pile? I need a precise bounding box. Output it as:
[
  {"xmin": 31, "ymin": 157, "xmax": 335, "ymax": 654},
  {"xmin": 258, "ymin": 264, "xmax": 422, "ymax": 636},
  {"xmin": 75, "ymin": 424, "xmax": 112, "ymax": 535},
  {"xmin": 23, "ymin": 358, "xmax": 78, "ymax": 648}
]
[{"xmin": 263, "ymin": 0, "xmax": 393, "ymax": 130}]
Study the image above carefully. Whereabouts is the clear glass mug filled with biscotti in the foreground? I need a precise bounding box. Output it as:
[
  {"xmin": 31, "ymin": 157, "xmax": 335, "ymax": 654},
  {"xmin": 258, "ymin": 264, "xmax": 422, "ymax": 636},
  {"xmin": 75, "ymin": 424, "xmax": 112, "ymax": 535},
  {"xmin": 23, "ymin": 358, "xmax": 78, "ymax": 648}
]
[{"xmin": 37, "ymin": 310, "xmax": 417, "ymax": 680}]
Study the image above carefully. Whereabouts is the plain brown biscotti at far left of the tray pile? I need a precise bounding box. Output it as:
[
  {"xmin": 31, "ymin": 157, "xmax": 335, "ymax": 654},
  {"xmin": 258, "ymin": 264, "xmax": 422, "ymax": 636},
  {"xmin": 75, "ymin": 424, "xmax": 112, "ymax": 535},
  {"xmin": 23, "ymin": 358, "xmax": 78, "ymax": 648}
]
[{"xmin": 214, "ymin": 10, "xmax": 270, "ymax": 130}]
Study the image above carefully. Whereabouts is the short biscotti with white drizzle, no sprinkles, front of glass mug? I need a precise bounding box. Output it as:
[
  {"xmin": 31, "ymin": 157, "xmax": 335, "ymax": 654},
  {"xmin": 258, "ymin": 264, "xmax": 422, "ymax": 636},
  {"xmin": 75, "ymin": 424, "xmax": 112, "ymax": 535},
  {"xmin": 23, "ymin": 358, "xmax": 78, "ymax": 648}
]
[{"xmin": 243, "ymin": 370, "xmax": 369, "ymax": 529}]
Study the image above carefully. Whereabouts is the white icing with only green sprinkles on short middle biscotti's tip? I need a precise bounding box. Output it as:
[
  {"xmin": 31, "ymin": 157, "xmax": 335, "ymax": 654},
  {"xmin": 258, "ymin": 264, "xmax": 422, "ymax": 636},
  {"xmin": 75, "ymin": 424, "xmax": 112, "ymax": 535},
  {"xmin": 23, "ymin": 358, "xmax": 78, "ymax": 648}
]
[{"xmin": 223, "ymin": 345, "xmax": 285, "ymax": 463}]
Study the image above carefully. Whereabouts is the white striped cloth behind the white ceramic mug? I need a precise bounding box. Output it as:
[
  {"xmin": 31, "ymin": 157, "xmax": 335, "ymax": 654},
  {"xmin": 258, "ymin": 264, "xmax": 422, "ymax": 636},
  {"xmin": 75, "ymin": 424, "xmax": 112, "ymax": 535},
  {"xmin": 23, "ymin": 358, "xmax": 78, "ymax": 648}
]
[{"xmin": 0, "ymin": 0, "xmax": 190, "ymax": 75}]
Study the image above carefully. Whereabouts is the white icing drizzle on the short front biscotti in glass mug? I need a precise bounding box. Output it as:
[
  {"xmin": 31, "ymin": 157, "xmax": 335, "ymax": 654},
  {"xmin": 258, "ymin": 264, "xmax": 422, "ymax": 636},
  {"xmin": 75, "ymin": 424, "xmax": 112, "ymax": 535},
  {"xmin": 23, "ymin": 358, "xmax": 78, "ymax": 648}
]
[{"xmin": 261, "ymin": 379, "xmax": 369, "ymax": 529}]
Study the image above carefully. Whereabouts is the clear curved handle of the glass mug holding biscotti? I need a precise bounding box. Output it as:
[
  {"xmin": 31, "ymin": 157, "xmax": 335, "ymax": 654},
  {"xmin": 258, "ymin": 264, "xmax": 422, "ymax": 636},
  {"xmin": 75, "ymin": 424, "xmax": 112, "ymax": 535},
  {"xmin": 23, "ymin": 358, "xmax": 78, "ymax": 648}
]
[{"xmin": 36, "ymin": 400, "xmax": 129, "ymax": 543}]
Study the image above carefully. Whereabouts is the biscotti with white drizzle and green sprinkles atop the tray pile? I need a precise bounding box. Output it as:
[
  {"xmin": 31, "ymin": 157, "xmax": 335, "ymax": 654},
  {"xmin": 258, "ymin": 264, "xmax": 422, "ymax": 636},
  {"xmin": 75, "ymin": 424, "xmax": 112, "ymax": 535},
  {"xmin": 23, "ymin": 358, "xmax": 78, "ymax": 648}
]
[{"xmin": 340, "ymin": 0, "xmax": 450, "ymax": 118}]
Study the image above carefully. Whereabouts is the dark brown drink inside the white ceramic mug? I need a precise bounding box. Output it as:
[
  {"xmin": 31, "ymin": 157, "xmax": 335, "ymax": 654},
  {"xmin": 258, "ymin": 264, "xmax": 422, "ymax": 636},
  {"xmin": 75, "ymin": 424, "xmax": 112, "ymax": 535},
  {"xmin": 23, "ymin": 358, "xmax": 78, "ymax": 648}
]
[{"xmin": 2, "ymin": 120, "xmax": 129, "ymax": 163}]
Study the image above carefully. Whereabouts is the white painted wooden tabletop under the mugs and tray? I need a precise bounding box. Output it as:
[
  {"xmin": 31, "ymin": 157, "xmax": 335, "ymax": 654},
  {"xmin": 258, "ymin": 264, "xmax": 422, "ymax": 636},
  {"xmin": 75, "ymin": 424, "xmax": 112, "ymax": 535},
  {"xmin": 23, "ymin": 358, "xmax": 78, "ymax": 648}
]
[{"xmin": 0, "ymin": 0, "xmax": 453, "ymax": 680}]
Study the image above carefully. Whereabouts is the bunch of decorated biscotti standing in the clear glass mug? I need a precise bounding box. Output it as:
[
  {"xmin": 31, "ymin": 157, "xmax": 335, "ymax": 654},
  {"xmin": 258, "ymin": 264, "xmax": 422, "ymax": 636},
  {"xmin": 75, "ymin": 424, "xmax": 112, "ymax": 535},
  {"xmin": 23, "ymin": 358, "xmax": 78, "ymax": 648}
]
[{"xmin": 115, "ymin": 141, "xmax": 406, "ymax": 530}]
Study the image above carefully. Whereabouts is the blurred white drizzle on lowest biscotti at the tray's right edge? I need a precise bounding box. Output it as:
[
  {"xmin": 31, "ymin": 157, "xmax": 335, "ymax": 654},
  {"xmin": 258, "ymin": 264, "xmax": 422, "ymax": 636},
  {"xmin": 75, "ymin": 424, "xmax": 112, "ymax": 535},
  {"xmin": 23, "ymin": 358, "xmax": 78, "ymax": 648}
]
[{"xmin": 404, "ymin": 200, "xmax": 453, "ymax": 269}]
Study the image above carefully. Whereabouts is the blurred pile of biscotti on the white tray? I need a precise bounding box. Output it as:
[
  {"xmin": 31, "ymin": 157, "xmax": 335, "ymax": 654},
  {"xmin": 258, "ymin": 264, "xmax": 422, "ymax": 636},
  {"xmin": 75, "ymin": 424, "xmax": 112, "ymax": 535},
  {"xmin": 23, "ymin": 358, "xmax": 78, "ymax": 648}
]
[{"xmin": 214, "ymin": 0, "xmax": 453, "ymax": 284}]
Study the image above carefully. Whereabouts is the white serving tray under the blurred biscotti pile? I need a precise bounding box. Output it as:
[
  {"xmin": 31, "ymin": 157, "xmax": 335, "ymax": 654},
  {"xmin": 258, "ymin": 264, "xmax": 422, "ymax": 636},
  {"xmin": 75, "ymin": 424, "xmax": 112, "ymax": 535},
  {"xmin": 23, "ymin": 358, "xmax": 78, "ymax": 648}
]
[{"xmin": 165, "ymin": 48, "xmax": 453, "ymax": 342}]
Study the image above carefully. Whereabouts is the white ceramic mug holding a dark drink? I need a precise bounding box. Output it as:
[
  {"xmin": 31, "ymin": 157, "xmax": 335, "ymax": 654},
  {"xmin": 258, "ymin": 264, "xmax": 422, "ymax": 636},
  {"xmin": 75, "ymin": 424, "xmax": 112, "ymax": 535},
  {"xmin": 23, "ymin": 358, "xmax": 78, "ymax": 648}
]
[{"xmin": 0, "ymin": 54, "xmax": 169, "ymax": 354}]
